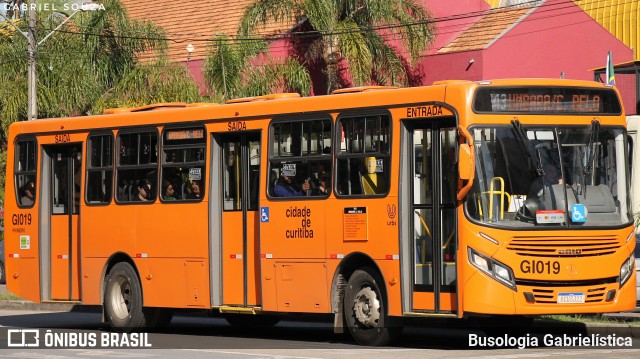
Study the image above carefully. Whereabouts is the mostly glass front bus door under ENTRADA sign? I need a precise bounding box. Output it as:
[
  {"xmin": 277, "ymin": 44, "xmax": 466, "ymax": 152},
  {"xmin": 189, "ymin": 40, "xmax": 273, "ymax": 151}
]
[{"xmin": 406, "ymin": 118, "xmax": 457, "ymax": 313}]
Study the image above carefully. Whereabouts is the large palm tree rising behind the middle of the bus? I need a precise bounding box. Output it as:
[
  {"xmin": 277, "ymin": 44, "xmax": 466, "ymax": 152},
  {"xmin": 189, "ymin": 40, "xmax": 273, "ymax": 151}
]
[{"xmin": 205, "ymin": 0, "xmax": 434, "ymax": 98}]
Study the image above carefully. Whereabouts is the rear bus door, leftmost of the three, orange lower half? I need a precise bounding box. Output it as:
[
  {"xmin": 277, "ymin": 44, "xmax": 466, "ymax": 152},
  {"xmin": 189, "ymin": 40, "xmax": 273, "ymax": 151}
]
[{"xmin": 44, "ymin": 144, "xmax": 82, "ymax": 300}]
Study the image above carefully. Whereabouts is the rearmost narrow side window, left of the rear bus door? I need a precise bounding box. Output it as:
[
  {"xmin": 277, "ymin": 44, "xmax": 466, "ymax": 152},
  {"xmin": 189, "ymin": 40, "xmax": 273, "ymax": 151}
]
[{"xmin": 14, "ymin": 139, "xmax": 38, "ymax": 208}]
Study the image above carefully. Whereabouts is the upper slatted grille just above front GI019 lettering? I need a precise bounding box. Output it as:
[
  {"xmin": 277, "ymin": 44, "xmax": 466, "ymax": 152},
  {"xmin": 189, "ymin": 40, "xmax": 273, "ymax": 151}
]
[{"xmin": 507, "ymin": 236, "xmax": 621, "ymax": 257}]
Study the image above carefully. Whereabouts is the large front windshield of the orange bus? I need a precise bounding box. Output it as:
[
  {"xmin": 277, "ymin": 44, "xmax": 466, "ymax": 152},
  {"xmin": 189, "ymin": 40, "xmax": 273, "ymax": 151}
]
[{"xmin": 466, "ymin": 125, "xmax": 633, "ymax": 228}]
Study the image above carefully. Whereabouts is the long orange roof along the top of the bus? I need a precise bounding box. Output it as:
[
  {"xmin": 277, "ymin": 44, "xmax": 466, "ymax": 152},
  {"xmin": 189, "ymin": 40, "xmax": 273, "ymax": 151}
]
[{"xmin": 10, "ymin": 79, "xmax": 610, "ymax": 139}]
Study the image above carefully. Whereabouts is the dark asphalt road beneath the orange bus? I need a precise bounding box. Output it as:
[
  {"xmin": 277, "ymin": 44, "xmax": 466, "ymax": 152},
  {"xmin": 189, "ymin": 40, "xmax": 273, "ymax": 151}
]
[{"xmin": 0, "ymin": 310, "xmax": 640, "ymax": 359}]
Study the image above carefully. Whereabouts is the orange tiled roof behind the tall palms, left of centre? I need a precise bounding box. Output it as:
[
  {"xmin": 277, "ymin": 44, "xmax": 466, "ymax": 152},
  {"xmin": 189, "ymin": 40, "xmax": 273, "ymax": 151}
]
[{"xmin": 120, "ymin": 0, "xmax": 293, "ymax": 61}]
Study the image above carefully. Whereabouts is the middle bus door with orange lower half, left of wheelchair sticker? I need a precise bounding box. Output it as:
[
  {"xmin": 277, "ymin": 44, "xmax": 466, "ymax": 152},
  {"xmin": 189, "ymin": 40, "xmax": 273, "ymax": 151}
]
[{"xmin": 219, "ymin": 132, "xmax": 261, "ymax": 306}]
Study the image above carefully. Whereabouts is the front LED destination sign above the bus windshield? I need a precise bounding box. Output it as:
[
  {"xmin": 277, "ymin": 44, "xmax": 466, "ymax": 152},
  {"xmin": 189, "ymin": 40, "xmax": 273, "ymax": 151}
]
[{"xmin": 473, "ymin": 87, "xmax": 622, "ymax": 115}]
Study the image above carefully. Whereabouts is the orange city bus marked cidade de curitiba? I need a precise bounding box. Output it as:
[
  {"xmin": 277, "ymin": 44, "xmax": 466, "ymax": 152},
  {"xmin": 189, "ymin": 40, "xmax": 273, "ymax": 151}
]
[{"xmin": 5, "ymin": 79, "xmax": 636, "ymax": 345}]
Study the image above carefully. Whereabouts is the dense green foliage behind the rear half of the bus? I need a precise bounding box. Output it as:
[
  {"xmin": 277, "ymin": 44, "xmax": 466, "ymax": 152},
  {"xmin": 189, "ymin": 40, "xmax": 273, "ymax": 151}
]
[{"xmin": 0, "ymin": 0, "xmax": 201, "ymax": 207}]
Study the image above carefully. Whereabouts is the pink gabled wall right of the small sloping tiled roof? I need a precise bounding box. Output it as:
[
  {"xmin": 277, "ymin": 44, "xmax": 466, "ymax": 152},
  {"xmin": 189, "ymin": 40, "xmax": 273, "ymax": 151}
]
[{"xmin": 483, "ymin": 0, "xmax": 633, "ymax": 80}]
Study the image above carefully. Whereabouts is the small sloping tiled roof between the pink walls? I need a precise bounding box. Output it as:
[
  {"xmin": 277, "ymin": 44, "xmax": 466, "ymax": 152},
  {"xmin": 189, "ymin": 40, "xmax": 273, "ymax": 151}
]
[{"xmin": 437, "ymin": 7, "xmax": 532, "ymax": 54}]
